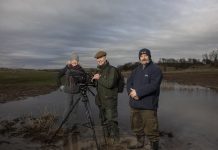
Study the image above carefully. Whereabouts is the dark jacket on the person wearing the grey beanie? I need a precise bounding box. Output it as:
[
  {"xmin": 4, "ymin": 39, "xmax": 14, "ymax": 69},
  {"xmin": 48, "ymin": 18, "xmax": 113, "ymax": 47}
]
[{"xmin": 57, "ymin": 65, "xmax": 86, "ymax": 94}]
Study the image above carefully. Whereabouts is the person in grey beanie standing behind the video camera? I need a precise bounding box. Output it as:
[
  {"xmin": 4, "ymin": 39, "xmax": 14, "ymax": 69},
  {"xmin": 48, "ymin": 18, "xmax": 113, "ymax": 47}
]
[{"xmin": 57, "ymin": 52, "xmax": 86, "ymax": 134}]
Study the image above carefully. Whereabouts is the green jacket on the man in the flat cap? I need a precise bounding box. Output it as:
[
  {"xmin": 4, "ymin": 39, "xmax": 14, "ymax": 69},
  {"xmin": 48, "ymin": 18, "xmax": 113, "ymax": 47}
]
[{"xmin": 96, "ymin": 62, "xmax": 119, "ymax": 108}]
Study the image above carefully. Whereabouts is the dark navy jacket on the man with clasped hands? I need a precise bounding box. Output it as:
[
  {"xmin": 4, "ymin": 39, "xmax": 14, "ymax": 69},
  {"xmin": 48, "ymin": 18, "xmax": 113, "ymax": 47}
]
[{"xmin": 127, "ymin": 61, "xmax": 163, "ymax": 110}]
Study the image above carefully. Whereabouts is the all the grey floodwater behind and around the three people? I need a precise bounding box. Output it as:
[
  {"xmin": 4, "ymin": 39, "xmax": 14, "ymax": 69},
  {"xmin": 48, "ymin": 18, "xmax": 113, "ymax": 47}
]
[{"xmin": 0, "ymin": 82, "xmax": 218, "ymax": 150}]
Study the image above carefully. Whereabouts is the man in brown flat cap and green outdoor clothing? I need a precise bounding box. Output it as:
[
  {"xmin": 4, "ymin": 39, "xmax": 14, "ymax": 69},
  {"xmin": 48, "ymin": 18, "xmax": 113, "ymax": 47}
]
[{"xmin": 92, "ymin": 51, "xmax": 119, "ymax": 144}]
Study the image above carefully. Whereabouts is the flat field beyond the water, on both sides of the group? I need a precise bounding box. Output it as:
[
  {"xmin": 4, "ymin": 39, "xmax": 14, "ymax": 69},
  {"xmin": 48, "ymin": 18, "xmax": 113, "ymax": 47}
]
[{"xmin": 0, "ymin": 69, "xmax": 218, "ymax": 103}]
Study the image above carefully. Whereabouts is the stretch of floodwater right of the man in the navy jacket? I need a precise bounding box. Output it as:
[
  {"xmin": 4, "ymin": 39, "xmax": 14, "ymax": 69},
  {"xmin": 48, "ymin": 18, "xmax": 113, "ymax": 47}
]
[{"xmin": 159, "ymin": 82, "xmax": 218, "ymax": 149}]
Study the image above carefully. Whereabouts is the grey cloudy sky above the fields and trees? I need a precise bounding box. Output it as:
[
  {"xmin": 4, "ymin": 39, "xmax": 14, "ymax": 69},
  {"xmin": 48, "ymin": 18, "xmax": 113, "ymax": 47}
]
[{"xmin": 0, "ymin": 0, "xmax": 218, "ymax": 69}]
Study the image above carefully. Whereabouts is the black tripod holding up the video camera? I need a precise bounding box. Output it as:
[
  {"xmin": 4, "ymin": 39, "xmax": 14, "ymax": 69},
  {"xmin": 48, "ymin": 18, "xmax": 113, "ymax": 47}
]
[{"xmin": 48, "ymin": 84, "xmax": 100, "ymax": 150}]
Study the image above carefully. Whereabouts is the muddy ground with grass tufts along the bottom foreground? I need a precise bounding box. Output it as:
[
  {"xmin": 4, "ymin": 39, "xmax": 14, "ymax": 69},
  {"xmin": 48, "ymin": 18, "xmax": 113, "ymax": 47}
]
[{"xmin": 0, "ymin": 114, "xmax": 177, "ymax": 150}]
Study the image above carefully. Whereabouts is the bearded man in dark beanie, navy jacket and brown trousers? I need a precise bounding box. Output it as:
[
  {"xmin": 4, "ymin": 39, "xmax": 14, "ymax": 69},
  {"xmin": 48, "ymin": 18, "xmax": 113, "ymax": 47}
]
[{"xmin": 127, "ymin": 48, "xmax": 162, "ymax": 150}]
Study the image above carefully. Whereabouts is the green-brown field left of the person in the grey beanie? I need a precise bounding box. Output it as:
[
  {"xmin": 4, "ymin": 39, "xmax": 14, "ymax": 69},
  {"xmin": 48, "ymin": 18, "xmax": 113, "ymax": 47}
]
[{"xmin": 0, "ymin": 69, "xmax": 57, "ymax": 103}]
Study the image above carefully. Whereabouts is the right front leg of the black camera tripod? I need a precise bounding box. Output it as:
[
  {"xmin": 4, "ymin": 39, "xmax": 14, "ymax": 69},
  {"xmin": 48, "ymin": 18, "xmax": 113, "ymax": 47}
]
[{"xmin": 84, "ymin": 97, "xmax": 100, "ymax": 150}]
